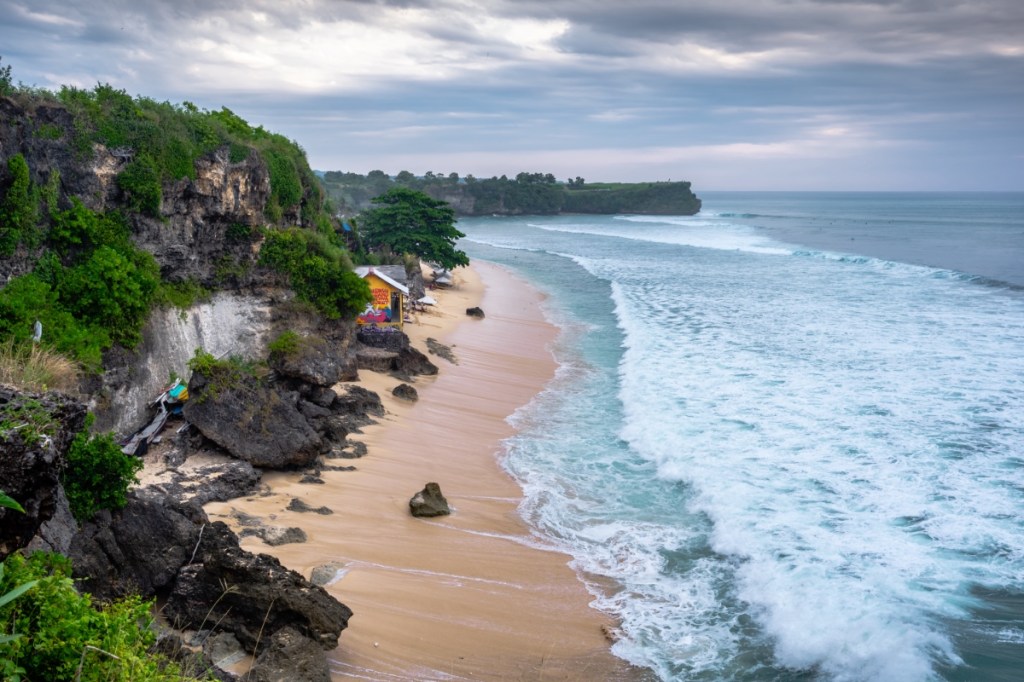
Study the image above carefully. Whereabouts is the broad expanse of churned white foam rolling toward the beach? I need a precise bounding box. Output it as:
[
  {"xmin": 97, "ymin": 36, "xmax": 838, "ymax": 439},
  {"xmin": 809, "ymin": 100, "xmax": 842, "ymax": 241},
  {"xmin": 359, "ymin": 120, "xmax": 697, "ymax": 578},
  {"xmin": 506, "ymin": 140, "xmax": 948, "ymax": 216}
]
[{"xmin": 609, "ymin": 246, "xmax": 1024, "ymax": 680}]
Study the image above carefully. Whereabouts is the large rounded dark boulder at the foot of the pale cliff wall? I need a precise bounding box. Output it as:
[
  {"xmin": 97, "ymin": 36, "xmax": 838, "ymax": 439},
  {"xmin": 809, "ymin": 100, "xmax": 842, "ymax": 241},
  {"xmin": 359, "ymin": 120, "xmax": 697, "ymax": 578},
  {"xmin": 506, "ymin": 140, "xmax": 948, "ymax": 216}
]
[{"xmin": 184, "ymin": 372, "xmax": 323, "ymax": 469}]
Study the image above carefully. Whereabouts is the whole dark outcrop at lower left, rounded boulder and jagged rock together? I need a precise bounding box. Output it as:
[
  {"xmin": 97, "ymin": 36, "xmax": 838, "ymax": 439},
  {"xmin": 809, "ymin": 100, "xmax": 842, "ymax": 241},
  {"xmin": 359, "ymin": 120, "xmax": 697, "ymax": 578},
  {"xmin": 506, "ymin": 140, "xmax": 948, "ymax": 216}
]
[{"xmin": 70, "ymin": 489, "xmax": 352, "ymax": 680}]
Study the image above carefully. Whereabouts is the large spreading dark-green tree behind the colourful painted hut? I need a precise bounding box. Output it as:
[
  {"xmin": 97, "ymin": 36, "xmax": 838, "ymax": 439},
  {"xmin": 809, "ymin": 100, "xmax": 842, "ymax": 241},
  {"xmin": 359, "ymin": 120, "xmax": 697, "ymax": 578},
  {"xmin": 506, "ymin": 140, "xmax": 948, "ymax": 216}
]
[{"xmin": 359, "ymin": 187, "xmax": 469, "ymax": 268}]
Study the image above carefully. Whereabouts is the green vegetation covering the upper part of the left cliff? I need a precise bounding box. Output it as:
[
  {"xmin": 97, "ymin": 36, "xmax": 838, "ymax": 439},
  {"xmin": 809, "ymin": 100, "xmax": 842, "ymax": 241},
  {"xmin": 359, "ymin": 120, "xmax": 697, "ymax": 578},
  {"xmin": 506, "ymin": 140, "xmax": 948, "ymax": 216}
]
[{"xmin": 0, "ymin": 62, "xmax": 369, "ymax": 371}]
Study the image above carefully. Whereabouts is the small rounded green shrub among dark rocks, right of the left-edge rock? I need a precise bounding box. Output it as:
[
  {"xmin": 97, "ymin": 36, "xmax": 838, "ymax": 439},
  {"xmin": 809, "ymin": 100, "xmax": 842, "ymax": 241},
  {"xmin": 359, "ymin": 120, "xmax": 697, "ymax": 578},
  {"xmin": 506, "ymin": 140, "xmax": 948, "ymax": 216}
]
[{"xmin": 60, "ymin": 419, "xmax": 142, "ymax": 521}]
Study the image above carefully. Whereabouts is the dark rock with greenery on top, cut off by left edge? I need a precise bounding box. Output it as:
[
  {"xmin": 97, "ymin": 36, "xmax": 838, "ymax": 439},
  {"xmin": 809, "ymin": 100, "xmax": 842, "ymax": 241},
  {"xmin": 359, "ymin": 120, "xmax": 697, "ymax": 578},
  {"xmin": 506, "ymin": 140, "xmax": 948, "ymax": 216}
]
[{"xmin": 0, "ymin": 386, "xmax": 86, "ymax": 558}]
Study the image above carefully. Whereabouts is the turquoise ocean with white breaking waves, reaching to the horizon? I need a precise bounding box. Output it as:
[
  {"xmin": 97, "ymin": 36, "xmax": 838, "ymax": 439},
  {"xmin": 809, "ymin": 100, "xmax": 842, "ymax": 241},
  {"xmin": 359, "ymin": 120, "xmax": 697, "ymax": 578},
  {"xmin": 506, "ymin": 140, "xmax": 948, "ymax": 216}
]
[{"xmin": 459, "ymin": 193, "xmax": 1024, "ymax": 682}]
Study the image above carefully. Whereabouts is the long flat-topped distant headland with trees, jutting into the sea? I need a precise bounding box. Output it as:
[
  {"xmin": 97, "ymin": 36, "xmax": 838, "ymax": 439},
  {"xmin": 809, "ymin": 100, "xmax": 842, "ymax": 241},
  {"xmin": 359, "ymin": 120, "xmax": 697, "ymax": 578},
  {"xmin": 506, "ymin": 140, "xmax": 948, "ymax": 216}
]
[{"xmin": 319, "ymin": 170, "xmax": 700, "ymax": 216}]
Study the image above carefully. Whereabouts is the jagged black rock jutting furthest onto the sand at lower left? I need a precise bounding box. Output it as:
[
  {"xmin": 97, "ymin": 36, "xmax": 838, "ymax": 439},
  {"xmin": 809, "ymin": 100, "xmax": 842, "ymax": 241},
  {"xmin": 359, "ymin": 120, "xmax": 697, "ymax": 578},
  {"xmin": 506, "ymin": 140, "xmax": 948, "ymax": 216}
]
[{"xmin": 165, "ymin": 521, "xmax": 352, "ymax": 651}]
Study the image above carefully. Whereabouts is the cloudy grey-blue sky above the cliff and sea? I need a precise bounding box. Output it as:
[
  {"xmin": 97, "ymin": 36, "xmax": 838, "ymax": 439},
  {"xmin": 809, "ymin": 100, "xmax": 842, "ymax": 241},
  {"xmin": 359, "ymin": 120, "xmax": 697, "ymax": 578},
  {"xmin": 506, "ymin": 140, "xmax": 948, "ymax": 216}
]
[{"xmin": 0, "ymin": 0, "xmax": 1024, "ymax": 188}]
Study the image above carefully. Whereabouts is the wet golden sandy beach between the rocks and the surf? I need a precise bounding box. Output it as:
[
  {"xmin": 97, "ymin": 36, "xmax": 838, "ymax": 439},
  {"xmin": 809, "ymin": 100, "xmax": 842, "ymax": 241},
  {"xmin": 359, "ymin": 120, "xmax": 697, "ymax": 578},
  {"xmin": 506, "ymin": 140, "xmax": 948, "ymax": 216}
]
[{"xmin": 207, "ymin": 263, "xmax": 642, "ymax": 680}]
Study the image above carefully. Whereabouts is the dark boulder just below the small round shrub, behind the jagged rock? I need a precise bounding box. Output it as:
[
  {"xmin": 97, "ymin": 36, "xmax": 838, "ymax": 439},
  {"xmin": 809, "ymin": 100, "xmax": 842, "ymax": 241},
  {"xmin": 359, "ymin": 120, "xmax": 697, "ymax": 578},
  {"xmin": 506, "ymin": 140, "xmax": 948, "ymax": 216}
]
[{"xmin": 69, "ymin": 493, "xmax": 209, "ymax": 600}]
